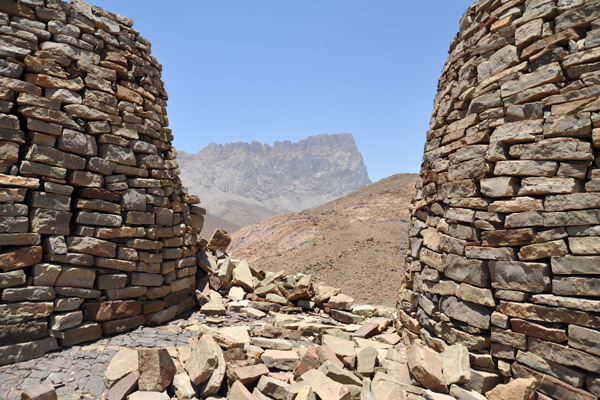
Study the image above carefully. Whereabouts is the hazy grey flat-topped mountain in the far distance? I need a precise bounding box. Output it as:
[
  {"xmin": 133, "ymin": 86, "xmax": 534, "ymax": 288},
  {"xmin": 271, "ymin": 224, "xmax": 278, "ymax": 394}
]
[{"xmin": 177, "ymin": 133, "xmax": 371, "ymax": 228}]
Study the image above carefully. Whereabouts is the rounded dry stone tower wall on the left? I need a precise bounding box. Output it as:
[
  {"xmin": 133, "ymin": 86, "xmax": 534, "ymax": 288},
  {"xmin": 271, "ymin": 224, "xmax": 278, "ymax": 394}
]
[{"xmin": 0, "ymin": 0, "xmax": 204, "ymax": 364}]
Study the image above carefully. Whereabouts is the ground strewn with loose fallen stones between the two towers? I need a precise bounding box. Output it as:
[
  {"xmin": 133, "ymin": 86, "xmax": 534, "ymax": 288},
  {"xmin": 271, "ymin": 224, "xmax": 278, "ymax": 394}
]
[{"xmin": 10, "ymin": 251, "xmax": 536, "ymax": 400}]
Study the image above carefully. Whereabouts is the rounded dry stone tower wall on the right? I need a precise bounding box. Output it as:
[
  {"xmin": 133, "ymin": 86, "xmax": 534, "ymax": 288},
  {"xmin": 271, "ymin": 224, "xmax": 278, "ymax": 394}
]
[{"xmin": 398, "ymin": 0, "xmax": 600, "ymax": 399}]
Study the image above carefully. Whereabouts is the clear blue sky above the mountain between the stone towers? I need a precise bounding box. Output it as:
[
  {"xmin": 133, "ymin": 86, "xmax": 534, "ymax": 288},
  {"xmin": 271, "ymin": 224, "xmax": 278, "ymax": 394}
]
[{"xmin": 90, "ymin": 0, "xmax": 472, "ymax": 182}]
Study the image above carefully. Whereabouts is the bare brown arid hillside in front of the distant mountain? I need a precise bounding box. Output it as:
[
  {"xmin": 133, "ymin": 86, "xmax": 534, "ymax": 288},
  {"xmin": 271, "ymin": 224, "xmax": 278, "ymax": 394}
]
[{"xmin": 229, "ymin": 174, "xmax": 416, "ymax": 306}]
